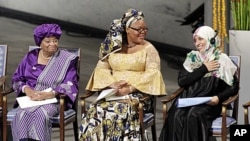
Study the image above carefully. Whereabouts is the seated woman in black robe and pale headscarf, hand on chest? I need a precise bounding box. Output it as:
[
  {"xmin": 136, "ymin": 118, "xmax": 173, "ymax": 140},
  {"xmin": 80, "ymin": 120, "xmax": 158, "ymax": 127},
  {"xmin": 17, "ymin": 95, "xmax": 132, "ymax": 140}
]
[{"xmin": 159, "ymin": 26, "xmax": 239, "ymax": 141}]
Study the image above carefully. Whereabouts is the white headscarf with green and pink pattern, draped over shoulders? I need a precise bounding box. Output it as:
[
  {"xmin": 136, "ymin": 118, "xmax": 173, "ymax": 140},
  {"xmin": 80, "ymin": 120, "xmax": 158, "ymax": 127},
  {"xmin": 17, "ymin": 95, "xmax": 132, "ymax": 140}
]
[{"xmin": 183, "ymin": 26, "xmax": 237, "ymax": 86}]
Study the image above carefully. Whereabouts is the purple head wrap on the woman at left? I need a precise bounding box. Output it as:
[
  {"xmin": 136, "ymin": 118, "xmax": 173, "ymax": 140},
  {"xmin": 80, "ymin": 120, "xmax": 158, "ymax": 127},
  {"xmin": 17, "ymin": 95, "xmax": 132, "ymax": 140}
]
[{"xmin": 34, "ymin": 24, "xmax": 62, "ymax": 46}]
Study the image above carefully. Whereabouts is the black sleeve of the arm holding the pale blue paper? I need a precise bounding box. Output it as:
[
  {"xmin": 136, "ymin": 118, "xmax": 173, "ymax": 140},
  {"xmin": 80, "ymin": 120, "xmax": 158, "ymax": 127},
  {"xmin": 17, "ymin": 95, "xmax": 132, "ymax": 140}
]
[{"xmin": 218, "ymin": 76, "xmax": 239, "ymax": 102}]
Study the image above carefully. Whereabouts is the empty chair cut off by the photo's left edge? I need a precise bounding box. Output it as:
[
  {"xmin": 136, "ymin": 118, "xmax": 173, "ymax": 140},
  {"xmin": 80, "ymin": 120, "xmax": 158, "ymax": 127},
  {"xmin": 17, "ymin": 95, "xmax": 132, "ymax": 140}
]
[{"xmin": 0, "ymin": 45, "xmax": 8, "ymax": 140}]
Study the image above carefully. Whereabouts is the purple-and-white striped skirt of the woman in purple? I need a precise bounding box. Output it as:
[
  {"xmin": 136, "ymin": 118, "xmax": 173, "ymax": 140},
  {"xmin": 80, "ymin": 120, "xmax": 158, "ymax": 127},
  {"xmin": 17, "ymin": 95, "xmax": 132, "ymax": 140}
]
[{"xmin": 11, "ymin": 104, "xmax": 59, "ymax": 141}]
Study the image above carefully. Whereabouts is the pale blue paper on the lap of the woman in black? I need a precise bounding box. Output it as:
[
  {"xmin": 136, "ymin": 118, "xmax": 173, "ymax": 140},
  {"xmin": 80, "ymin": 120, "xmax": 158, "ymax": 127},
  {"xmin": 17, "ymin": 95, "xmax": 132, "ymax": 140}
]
[{"xmin": 177, "ymin": 97, "xmax": 212, "ymax": 108}]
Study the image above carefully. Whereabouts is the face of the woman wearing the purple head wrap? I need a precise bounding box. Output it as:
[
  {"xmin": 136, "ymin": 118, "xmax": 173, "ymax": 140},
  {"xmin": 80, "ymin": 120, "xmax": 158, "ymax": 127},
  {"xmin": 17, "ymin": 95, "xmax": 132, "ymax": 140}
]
[{"xmin": 40, "ymin": 36, "xmax": 58, "ymax": 53}]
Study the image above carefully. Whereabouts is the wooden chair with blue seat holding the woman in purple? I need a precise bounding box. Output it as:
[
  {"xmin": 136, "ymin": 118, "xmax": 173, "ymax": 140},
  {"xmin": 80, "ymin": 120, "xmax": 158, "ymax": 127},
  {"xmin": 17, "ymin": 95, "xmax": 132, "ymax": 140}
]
[{"xmin": 3, "ymin": 46, "xmax": 80, "ymax": 141}]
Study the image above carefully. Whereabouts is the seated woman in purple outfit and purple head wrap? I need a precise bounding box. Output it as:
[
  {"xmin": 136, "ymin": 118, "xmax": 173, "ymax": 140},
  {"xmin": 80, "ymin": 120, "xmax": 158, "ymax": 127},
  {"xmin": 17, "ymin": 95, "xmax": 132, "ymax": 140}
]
[{"xmin": 11, "ymin": 24, "xmax": 79, "ymax": 141}]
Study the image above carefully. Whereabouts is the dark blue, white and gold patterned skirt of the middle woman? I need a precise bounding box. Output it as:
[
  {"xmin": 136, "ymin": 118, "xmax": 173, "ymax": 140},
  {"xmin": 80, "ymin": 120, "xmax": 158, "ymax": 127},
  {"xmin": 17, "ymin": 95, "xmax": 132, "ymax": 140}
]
[{"xmin": 80, "ymin": 94, "xmax": 144, "ymax": 141}]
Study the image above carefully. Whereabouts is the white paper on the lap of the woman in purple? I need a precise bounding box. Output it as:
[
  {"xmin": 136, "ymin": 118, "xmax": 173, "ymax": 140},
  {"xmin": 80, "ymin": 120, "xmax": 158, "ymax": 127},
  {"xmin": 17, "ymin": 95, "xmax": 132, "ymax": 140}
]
[{"xmin": 16, "ymin": 88, "xmax": 57, "ymax": 108}]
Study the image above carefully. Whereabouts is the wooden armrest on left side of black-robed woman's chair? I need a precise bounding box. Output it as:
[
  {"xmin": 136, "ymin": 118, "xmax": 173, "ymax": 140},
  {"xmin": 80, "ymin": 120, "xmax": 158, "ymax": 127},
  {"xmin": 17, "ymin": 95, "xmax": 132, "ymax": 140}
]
[{"xmin": 161, "ymin": 88, "xmax": 184, "ymax": 121}]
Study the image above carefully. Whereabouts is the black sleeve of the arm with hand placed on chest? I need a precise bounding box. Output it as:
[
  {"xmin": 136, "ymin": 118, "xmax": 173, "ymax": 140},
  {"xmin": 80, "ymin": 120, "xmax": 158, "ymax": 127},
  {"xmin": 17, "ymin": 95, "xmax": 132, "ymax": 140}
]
[{"xmin": 178, "ymin": 64, "xmax": 208, "ymax": 87}]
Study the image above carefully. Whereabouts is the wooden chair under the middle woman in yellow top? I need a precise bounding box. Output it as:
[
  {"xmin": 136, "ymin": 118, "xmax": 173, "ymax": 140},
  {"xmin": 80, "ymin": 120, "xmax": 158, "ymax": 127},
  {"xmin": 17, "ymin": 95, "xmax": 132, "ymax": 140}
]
[{"xmin": 80, "ymin": 91, "xmax": 160, "ymax": 141}]
